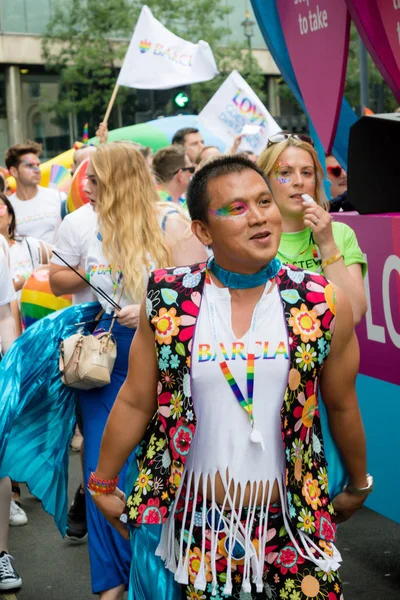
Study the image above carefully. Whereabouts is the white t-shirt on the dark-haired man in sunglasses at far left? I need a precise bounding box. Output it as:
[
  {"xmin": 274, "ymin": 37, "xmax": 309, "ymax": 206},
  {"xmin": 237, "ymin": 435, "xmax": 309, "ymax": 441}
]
[{"xmin": 10, "ymin": 186, "xmax": 63, "ymax": 244}]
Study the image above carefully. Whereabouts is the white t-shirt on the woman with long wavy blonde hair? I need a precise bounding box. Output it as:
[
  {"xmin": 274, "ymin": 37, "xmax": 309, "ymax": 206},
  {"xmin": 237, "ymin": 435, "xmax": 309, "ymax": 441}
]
[{"xmin": 86, "ymin": 232, "xmax": 148, "ymax": 313}]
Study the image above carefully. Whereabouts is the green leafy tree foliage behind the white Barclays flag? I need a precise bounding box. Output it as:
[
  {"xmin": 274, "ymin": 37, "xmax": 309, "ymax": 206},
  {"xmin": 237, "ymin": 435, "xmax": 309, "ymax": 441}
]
[{"xmin": 42, "ymin": 0, "xmax": 264, "ymax": 126}]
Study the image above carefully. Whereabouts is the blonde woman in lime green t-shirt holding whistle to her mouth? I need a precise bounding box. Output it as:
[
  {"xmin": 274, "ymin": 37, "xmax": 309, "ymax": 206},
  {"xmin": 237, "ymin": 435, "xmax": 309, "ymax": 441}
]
[{"xmin": 258, "ymin": 133, "xmax": 367, "ymax": 324}]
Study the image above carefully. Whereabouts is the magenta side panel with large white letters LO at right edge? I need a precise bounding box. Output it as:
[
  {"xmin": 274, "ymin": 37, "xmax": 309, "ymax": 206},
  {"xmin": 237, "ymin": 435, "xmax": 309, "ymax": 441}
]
[{"xmin": 335, "ymin": 213, "xmax": 400, "ymax": 385}]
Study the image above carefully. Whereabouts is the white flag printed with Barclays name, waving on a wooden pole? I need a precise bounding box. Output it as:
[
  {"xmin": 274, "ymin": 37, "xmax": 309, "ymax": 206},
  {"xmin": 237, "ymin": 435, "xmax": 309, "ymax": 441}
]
[{"xmin": 117, "ymin": 6, "xmax": 218, "ymax": 90}]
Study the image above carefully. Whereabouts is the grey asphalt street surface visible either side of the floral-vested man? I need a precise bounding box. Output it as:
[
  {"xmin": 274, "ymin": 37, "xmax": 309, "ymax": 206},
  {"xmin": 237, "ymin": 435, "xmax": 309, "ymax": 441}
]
[{"xmin": 1, "ymin": 454, "xmax": 400, "ymax": 600}]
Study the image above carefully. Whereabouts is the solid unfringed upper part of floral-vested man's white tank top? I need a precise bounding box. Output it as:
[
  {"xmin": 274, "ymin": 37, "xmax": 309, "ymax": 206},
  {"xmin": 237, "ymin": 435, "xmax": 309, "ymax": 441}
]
[{"xmin": 190, "ymin": 281, "xmax": 289, "ymax": 484}]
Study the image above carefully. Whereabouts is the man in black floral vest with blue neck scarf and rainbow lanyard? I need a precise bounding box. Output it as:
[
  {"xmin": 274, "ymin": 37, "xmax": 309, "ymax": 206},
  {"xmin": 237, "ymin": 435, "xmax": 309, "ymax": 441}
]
[{"xmin": 88, "ymin": 156, "xmax": 373, "ymax": 600}]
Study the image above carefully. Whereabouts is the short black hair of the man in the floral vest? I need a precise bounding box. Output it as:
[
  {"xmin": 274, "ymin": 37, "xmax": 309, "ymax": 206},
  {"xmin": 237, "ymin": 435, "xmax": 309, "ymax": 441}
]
[{"xmin": 186, "ymin": 155, "xmax": 268, "ymax": 223}]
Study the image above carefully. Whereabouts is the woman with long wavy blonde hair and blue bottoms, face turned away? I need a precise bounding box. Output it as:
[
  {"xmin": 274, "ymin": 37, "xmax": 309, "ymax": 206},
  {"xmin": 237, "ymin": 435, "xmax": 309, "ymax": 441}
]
[{"xmin": 80, "ymin": 142, "xmax": 206, "ymax": 600}]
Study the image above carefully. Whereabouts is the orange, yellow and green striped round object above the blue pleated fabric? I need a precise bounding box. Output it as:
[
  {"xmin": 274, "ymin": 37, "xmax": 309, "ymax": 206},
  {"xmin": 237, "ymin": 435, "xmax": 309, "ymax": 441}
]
[{"xmin": 21, "ymin": 265, "xmax": 72, "ymax": 328}]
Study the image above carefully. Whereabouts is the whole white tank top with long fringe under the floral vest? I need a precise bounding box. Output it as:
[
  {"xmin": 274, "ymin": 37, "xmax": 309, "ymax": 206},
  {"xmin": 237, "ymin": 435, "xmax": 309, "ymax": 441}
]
[{"xmin": 157, "ymin": 281, "xmax": 339, "ymax": 594}]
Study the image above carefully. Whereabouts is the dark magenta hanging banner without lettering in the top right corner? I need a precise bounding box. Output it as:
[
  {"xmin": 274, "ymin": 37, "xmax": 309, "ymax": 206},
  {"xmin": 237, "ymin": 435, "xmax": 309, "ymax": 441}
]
[{"xmin": 345, "ymin": 0, "xmax": 400, "ymax": 102}]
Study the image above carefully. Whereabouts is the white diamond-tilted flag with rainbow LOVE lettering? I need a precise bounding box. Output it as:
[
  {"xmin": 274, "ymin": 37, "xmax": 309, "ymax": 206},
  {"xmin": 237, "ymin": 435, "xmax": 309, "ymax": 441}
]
[{"xmin": 197, "ymin": 71, "xmax": 281, "ymax": 154}]
